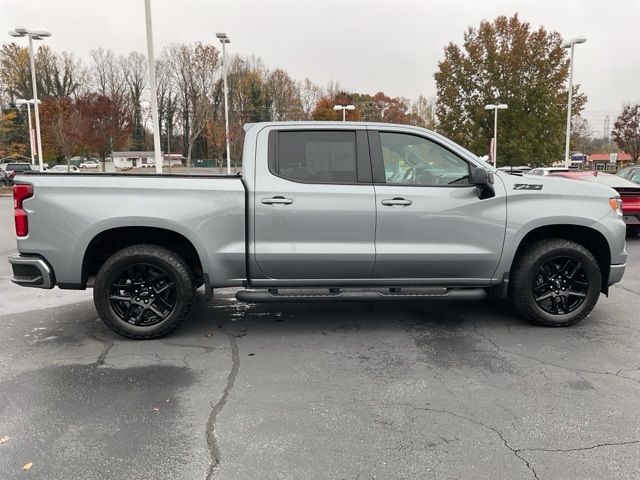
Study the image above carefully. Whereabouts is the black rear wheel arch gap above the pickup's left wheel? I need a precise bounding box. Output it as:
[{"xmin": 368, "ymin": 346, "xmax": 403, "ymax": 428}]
[{"xmin": 81, "ymin": 226, "xmax": 204, "ymax": 287}]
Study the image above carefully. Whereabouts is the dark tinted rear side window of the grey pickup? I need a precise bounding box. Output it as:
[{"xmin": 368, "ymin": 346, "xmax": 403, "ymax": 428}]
[{"xmin": 270, "ymin": 131, "xmax": 358, "ymax": 183}]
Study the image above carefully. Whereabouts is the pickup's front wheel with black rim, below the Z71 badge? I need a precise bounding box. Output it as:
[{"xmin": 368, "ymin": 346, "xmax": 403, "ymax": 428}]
[{"xmin": 511, "ymin": 239, "xmax": 602, "ymax": 327}]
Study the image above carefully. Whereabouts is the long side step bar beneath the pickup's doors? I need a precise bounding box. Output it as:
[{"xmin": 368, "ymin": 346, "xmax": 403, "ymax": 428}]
[{"xmin": 236, "ymin": 288, "xmax": 487, "ymax": 303}]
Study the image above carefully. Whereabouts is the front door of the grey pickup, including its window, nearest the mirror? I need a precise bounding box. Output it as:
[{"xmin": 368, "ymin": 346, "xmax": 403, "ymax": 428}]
[{"xmin": 369, "ymin": 131, "xmax": 506, "ymax": 284}]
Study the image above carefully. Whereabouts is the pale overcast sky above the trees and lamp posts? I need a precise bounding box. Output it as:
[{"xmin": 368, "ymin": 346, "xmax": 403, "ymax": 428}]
[{"xmin": 0, "ymin": 0, "xmax": 640, "ymax": 132}]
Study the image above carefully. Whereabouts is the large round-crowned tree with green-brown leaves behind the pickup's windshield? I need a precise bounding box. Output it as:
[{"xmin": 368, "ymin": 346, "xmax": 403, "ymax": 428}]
[{"xmin": 434, "ymin": 15, "xmax": 586, "ymax": 165}]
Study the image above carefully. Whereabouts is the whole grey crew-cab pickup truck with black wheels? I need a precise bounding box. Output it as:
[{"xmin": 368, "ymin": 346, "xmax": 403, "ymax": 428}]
[{"xmin": 9, "ymin": 122, "xmax": 626, "ymax": 339}]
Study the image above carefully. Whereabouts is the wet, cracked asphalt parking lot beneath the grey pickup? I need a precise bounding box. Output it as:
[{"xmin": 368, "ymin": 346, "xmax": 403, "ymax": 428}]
[{"xmin": 0, "ymin": 197, "xmax": 640, "ymax": 480}]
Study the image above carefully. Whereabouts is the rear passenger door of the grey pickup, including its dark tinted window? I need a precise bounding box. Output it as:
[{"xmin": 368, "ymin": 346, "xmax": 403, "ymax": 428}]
[{"xmin": 254, "ymin": 127, "xmax": 376, "ymax": 285}]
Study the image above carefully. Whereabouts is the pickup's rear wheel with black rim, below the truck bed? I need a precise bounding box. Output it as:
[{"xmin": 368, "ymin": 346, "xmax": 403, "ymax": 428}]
[{"xmin": 93, "ymin": 245, "xmax": 195, "ymax": 340}]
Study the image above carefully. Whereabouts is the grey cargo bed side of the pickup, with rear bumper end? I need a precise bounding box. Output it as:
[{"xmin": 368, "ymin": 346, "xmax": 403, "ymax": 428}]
[{"xmin": 16, "ymin": 173, "xmax": 246, "ymax": 288}]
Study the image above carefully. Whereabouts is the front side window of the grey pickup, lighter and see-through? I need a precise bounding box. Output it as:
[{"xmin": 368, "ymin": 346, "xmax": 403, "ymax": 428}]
[{"xmin": 380, "ymin": 132, "xmax": 470, "ymax": 186}]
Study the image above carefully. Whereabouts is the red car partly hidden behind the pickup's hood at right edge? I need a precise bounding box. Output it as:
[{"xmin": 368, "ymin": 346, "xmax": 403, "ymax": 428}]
[{"xmin": 550, "ymin": 170, "xmax": 640, "ymax": 235}]
